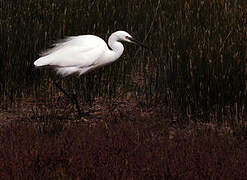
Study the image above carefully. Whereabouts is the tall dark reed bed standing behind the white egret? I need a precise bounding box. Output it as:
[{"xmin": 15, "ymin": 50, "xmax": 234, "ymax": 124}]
[{"xmin": 0, "ymin": 0, "xmax": 247, "ymax": 123}]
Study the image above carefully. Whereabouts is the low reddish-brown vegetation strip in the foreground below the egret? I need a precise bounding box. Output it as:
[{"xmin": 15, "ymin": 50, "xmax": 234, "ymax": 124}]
[{"xmin": 0, "ymin": 119, "xmax": 247, "ymax": 179}]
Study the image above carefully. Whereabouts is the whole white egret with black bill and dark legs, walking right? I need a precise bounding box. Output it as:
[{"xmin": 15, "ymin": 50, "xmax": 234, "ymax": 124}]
[{"xmin": 34, "ymin": 31, "xmax": 148, "ymax": 117}]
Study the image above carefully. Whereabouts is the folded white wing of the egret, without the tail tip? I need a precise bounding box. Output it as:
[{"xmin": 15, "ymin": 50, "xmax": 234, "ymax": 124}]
[{"xmin": 42, "ymin": 35, "xmax": 107, "ymax": 67}]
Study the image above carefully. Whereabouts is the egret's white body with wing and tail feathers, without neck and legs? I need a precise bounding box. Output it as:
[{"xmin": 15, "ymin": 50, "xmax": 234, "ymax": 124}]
[{"xmin": 34, "ymin": 35, "xmax": 108, "ymax": 76}]
